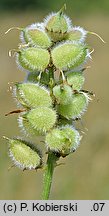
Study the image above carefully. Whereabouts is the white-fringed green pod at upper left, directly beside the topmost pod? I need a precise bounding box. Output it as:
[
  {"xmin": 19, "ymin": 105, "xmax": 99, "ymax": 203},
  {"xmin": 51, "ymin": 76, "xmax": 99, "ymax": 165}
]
[{"xmin": 21, "ymin": 23, "xmax": 51, "ymax": 49}]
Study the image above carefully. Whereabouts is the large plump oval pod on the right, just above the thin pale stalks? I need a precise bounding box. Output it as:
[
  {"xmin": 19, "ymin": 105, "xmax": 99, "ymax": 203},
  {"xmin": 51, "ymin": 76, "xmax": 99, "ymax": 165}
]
[{"xmin": 51, "ymin": 42, "xmax": 88, "ymax": 70}]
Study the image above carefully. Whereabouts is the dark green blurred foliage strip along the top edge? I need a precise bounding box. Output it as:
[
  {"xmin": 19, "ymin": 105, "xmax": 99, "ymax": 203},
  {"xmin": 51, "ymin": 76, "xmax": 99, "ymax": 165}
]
[{"xmin": 0, "ymin": 0, "xmax": 109, "ymax": 14}]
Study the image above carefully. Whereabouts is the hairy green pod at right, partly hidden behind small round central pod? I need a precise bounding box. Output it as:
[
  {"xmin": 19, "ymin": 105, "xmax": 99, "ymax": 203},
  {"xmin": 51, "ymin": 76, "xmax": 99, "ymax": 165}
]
[{"xmin": 57, "ymin": 93, "xmax": 89, "ymax": 119}]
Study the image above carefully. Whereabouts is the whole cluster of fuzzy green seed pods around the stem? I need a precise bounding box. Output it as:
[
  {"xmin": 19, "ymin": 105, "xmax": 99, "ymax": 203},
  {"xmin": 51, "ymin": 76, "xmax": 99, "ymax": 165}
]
[{"xmin": 5, "ymin": 5, "xmax": 90, "ymax": 169}]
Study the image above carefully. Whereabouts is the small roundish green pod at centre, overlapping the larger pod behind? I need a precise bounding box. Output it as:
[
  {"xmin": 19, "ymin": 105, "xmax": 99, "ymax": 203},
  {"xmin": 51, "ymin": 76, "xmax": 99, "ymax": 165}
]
[{"xmin": 53, "ymin": 84, "xmax": 72, "ymax": 104}]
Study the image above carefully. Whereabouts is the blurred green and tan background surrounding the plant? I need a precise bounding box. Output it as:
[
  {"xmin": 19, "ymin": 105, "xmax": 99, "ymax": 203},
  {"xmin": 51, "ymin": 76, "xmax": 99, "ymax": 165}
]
[{"xmin": 0, "ymin": 0, "xmax": 109, "ymax": 199}]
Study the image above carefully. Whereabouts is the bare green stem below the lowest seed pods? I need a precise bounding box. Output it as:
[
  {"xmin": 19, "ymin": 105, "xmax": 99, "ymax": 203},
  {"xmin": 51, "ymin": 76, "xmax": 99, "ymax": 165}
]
[{"xmin": 42, "ymin": 152, "xmax": 59, "ymax": 200}]
